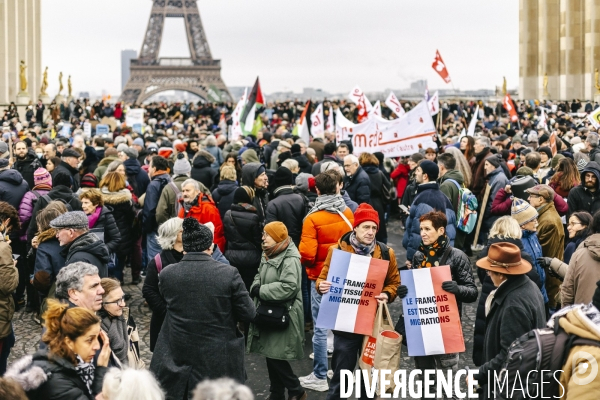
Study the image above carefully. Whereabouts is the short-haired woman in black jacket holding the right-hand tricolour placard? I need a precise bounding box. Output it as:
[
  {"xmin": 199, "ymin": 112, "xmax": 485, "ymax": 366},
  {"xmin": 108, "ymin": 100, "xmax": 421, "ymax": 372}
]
[{"xmin": 396, "ymin": 211, "xmax": 478, "ymax": 392}]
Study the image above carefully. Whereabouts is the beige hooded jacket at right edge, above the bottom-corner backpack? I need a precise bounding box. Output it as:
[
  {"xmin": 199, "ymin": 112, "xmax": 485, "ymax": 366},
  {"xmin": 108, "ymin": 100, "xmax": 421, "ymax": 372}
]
[{"xmin": 561, "ymin": 233, "xmax": 600, "ymax": 307}]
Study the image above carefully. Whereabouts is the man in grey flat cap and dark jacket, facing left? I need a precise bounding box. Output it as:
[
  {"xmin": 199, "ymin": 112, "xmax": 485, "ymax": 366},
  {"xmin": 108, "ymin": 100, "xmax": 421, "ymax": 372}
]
[{"xmin": 50, "ymin": 211, "xmax": 110, "ymax": 278}]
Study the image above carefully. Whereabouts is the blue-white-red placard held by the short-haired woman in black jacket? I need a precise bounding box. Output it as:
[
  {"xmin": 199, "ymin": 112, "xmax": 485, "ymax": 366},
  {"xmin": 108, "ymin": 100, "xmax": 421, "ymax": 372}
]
[{"xmin": 400, "ymin": 265, "xmax": 465, "ymax": 357}]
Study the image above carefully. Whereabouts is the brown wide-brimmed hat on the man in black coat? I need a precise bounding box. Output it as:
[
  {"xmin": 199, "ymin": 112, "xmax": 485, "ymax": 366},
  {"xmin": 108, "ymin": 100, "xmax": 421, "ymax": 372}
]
[{"xmin": 476, "ymin": 242, "xmax": 531, "ymax": 275}]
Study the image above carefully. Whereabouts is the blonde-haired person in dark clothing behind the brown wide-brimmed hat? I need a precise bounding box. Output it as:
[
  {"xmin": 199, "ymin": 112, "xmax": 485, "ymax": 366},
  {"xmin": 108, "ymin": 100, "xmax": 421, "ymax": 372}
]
[{"xmin": 473, "ymin": 215, "xmax": 543, "ymax": 366}]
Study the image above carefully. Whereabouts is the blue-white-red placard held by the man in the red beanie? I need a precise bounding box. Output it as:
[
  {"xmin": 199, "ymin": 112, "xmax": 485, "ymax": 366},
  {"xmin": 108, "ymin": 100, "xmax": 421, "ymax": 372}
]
[{"xmin": 317, "ymin": 249, "xmax": 389, "ymax": 335}]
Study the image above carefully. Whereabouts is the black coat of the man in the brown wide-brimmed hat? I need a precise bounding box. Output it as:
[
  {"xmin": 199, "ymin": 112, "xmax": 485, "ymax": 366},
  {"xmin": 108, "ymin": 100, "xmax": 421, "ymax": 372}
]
[{"xmin": 475, "ymin": 275, "xmax": 546, "ymax": 393}]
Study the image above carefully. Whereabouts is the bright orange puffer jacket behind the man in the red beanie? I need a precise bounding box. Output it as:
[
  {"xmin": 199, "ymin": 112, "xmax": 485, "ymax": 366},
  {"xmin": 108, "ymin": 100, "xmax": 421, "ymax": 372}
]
[{"xmin": 299, "ymin": 207, "xmax": 354, "ymax": 281}]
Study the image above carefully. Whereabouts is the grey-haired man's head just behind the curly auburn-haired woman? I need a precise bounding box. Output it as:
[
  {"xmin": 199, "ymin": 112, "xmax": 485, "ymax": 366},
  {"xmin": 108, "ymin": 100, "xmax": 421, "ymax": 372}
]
[{"xmin": 55, "ymin": 261, "xmax": 104, "ymax": 312}]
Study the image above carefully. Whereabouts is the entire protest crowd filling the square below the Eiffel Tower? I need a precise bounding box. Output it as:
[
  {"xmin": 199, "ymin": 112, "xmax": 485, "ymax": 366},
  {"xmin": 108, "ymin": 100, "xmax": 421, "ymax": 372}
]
[{"xmin": 0, "ymin": 85, "xmax": 600, "ymax": 400}]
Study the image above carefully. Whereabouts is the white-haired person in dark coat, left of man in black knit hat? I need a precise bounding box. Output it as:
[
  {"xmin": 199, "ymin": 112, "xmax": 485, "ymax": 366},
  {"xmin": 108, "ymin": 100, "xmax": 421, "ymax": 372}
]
[{"xmin": 142, "ymin": 218, "xmax": 183, "ymax": 351}]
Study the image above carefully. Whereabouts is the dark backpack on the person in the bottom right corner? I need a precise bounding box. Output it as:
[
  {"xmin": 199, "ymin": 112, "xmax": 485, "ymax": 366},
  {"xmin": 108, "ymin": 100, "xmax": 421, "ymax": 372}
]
[{"xmin": 490, "ymin": 316, "xmax": 600, "ymax": 400}]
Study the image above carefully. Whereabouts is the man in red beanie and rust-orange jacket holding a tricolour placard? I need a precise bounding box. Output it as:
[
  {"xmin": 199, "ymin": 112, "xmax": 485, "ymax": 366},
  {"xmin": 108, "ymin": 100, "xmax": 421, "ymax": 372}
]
[{"xmin": 316, "ymin": 203, "xmax": 400, "ymax": 400}]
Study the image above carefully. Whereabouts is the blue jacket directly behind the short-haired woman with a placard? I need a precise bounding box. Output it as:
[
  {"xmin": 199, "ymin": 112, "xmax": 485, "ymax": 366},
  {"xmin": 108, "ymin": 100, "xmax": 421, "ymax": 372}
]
[{"xmin": 402, "ymin": 182, "xmax": 456, "ymax": 260}]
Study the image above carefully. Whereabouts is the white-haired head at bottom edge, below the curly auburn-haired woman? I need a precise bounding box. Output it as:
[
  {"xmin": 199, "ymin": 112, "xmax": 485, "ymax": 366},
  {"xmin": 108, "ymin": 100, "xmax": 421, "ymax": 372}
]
[{"xmin": 102, "ymin": 368, "xmax": 165, "ymax": 400}]
